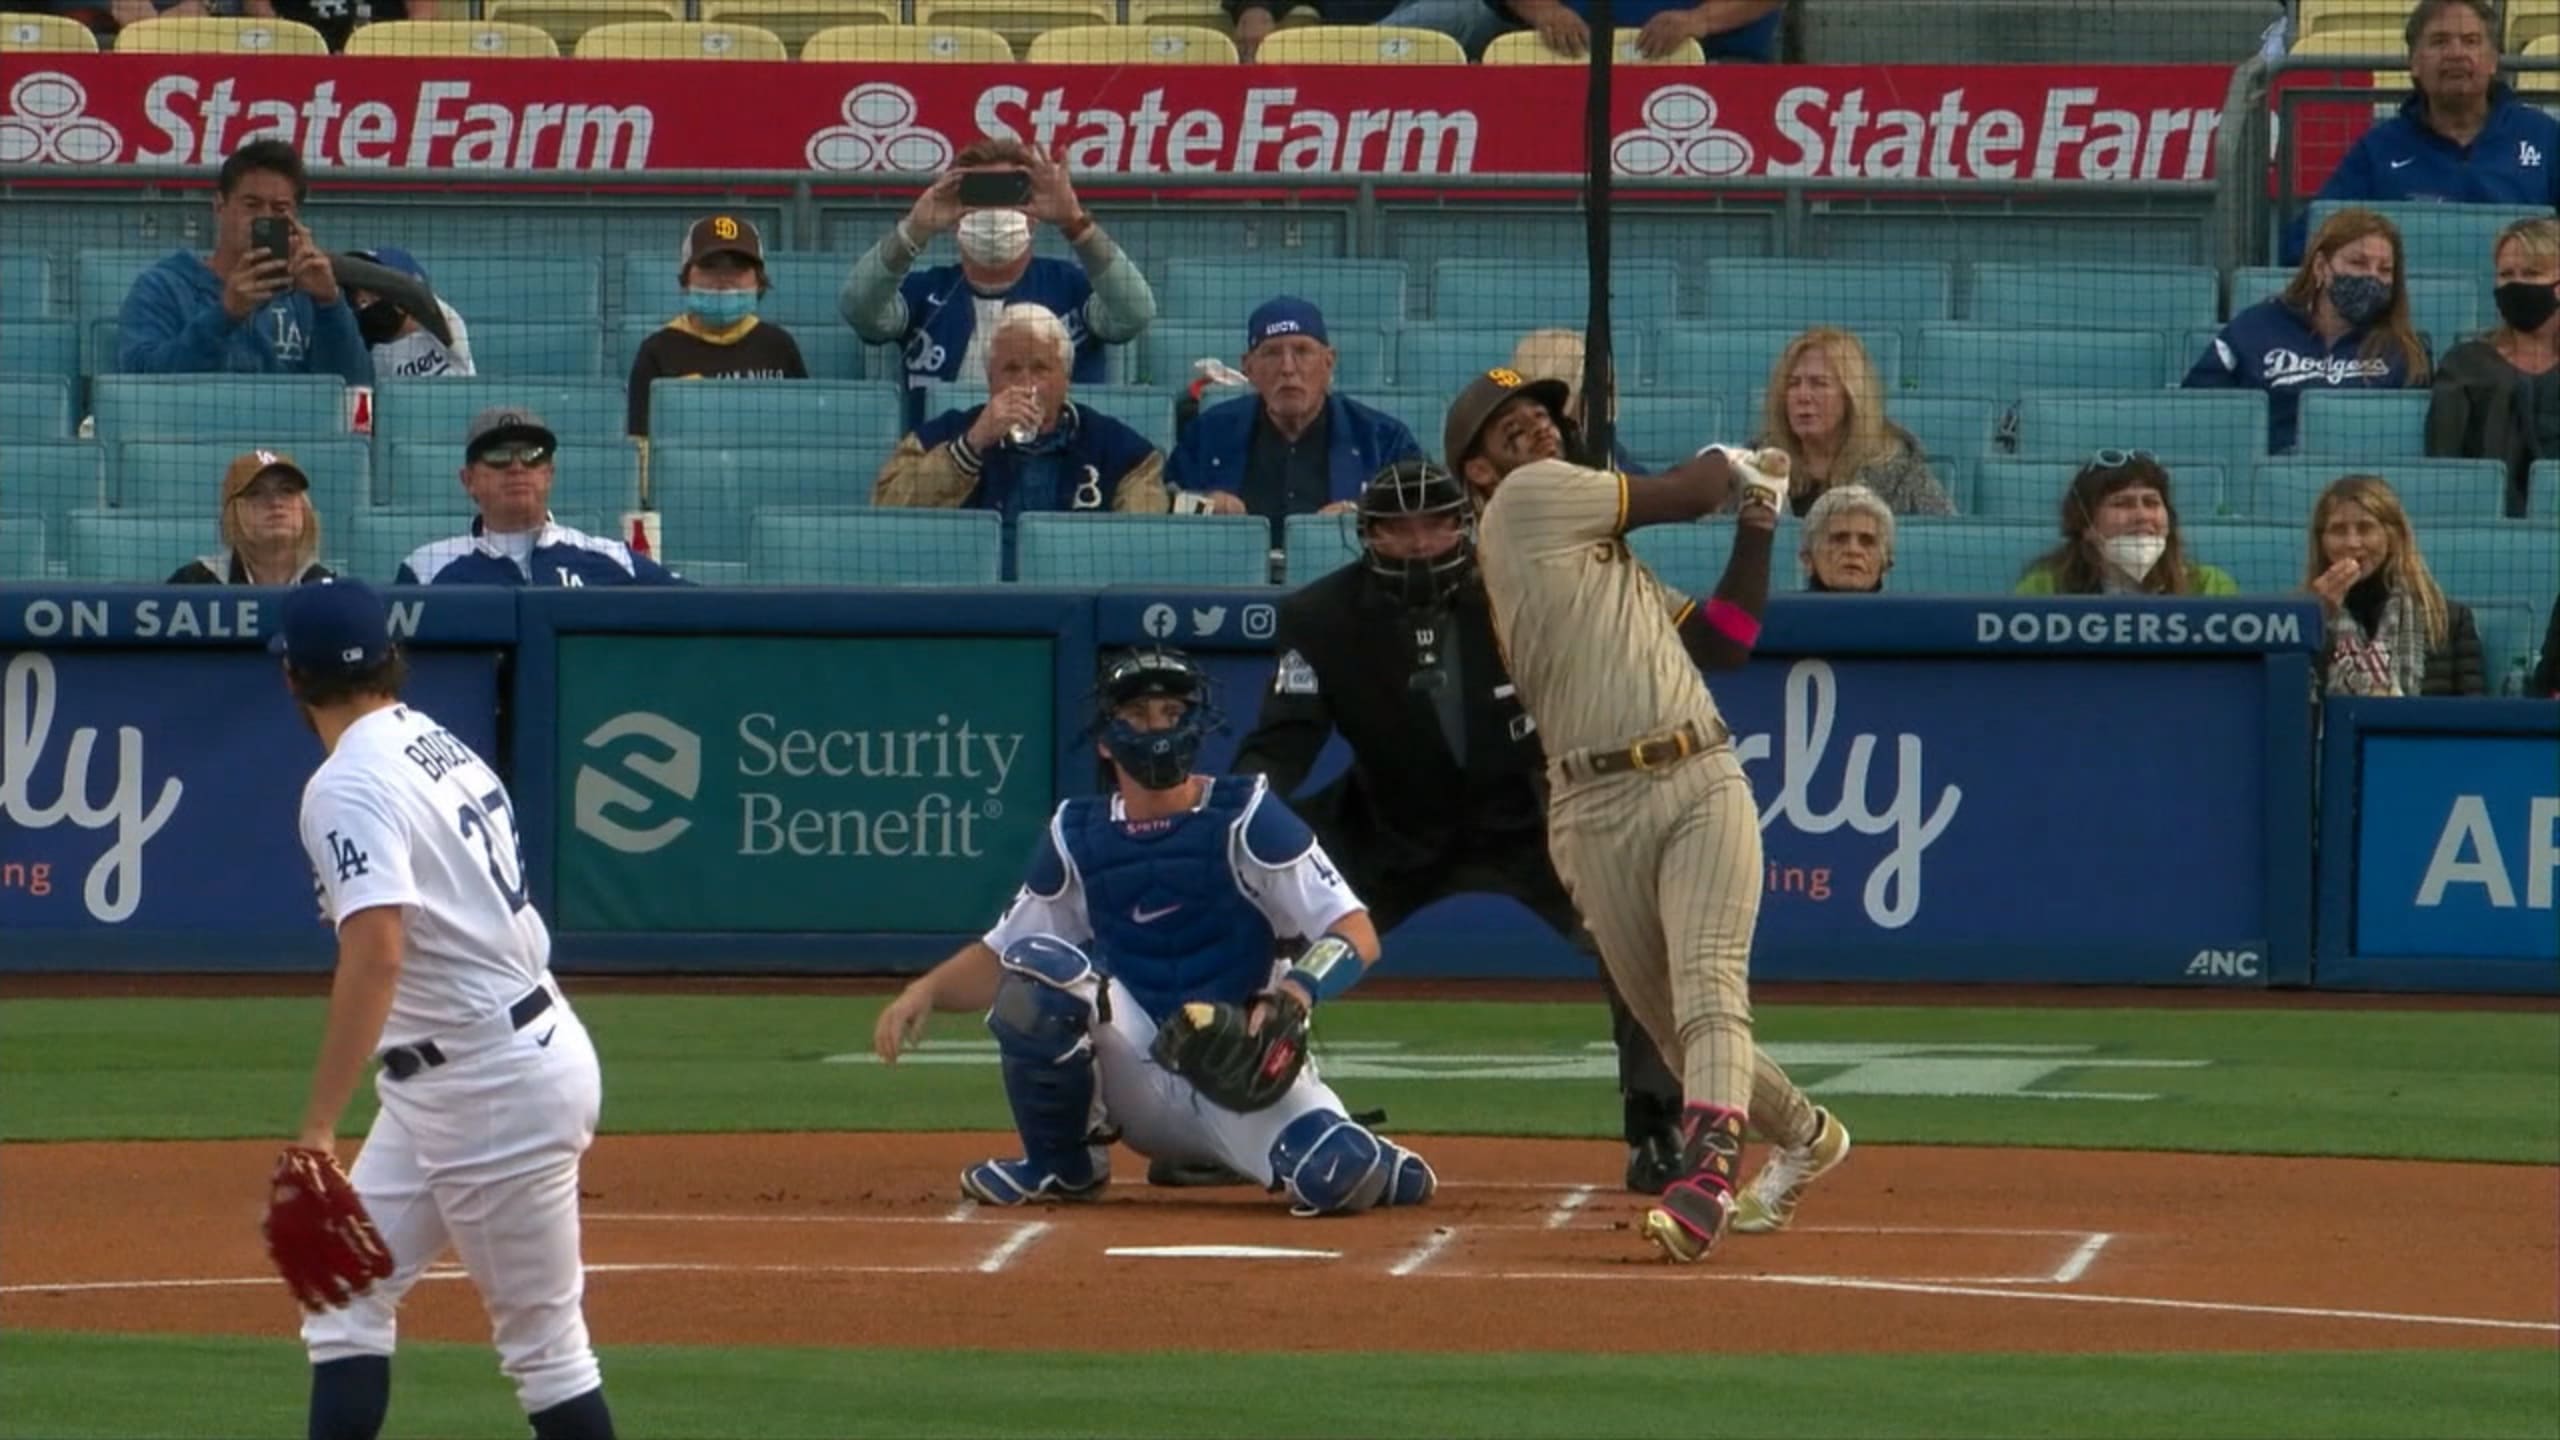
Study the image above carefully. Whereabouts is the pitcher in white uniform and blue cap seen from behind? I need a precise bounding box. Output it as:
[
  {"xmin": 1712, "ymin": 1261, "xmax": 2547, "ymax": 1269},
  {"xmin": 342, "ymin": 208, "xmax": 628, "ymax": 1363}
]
[{"xmin": 269, "ymin": 579, "xmax": 614, "ymax": 1440}]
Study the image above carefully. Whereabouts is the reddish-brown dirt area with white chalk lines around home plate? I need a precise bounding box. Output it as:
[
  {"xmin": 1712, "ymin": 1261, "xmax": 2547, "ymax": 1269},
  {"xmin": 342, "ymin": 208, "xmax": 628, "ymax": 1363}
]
[{"xmin": 0, "ymin": 1135, "xmax": 2560, "ymax": 1353}]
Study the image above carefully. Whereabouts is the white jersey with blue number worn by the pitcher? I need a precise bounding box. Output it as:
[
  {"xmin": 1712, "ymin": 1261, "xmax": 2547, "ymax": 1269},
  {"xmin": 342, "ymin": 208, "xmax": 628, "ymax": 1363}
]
[{"xmin": 302, "ymin": 705, "xmax": 550, "ymax": 1045}]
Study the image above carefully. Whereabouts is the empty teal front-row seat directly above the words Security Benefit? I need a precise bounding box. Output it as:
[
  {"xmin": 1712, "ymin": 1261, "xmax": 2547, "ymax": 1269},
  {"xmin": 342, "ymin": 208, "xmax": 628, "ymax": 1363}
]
[{"xmin": 748, "ymin": 507, "xmax": 1004, "ymax": 584}]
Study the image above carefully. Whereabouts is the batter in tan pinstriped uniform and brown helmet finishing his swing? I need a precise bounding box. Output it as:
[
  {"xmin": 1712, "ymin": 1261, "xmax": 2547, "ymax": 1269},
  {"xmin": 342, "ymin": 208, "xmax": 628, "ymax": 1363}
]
[{"xmin": 1444, "ymin": 369, "xmax": 1848, "ymax": 1261}]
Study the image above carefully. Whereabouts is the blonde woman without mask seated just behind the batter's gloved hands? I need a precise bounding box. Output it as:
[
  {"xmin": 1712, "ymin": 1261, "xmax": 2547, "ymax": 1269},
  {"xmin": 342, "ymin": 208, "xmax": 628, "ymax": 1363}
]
[{"xmin": 1725, "ymin": 325, "xmax": 1956, "ymax": 515}]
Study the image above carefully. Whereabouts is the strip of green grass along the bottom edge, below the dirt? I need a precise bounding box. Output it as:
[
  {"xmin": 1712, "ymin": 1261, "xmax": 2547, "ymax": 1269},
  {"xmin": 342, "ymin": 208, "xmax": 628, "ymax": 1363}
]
[{"xmin": 0, "ymin": 1335, "xmax": 2560, "ymax": 1440}]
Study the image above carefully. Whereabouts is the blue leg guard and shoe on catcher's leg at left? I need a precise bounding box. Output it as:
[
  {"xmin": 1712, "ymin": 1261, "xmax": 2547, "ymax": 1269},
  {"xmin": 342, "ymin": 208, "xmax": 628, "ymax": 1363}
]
[{"xmin": 960, "ymin": 935, "xmax": 1111, "ymax": 1204}]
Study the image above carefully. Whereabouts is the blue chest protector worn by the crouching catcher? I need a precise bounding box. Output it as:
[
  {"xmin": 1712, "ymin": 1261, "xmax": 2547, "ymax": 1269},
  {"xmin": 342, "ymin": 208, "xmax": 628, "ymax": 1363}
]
[{"xmin": 1057, "ymin": 776, "xmax": 1272, "ymax": 1020}]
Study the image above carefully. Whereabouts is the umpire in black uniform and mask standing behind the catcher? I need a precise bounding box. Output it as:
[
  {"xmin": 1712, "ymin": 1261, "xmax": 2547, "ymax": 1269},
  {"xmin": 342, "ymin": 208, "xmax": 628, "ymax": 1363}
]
[{"xmin": 1231, "ymin": 459, "xmax": 1679, "ymax": 1194}]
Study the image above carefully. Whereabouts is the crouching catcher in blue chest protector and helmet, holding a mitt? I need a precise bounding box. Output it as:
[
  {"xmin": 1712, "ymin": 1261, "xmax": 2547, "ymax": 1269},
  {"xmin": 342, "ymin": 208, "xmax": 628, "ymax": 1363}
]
[{"xmin": 873, "ymin": 648, "xmax": 1439, "ymax": 1215}]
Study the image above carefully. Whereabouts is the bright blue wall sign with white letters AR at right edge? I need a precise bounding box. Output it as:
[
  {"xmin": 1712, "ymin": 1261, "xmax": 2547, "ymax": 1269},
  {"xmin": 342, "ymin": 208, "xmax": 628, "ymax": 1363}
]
[{"xmin": 2353, "ymin": 735, "xmax": 2560, "ymax": 963}]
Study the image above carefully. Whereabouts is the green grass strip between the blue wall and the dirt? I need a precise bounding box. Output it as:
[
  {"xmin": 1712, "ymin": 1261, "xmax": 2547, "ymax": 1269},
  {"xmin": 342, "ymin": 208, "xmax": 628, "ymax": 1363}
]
[{"xmin": 0, "ymin": 994, "xmax": 2560, "ymax": 1163}]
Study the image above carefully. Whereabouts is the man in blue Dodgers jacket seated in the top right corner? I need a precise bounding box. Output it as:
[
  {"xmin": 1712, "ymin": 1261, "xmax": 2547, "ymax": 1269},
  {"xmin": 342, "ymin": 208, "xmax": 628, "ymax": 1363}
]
[{"xmin": 2284, "ymin": 0, "xmax": 2560, "ymax": 264}]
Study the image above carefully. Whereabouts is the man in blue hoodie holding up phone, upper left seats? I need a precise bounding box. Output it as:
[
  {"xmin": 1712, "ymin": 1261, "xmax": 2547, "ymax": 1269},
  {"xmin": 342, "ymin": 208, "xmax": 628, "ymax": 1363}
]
[{"xmin": 115, "ymin": 141, "xmax": 374, "ymax": 384}]
